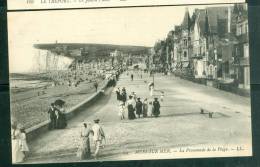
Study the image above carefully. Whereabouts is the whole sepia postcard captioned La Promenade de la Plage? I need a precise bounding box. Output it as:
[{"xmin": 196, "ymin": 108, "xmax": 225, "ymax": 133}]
[{"xmin": 7, "ymin": 3, "xmax": 252, "ymax": 164}]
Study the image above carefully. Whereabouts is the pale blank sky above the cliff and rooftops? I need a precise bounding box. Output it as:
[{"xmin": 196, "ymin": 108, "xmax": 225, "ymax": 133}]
[{"xmin": 8, "ymin": 3, "xmax": 233, "ymax": 72}]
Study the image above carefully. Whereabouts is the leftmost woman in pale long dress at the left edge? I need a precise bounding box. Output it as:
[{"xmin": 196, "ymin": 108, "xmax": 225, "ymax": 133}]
[{"xmin": 11, "ymin": 124, "xmax": 24, "ymax": 163}]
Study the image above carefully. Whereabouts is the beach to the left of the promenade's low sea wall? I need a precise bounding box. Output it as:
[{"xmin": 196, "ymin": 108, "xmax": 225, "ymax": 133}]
[{"xmin": 10, "ymin": 74, "xmax": 105, "ymax": 129}]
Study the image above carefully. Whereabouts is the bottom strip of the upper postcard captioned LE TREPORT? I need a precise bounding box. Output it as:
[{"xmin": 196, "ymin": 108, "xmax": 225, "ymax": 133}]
[{"xmin": 7, "ymin": 0, "xmax": 246, "ymax": 10}]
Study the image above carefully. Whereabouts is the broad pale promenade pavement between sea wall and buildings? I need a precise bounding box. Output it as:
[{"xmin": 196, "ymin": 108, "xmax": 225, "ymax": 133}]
[{"xmin": 24, "ymin": 73, "xmax": 251, "ymax": 163}]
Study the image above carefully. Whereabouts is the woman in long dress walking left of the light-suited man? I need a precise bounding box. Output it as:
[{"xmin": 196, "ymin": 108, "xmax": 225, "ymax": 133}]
[{"xmin": 77, "ymin": 123, "xmax": 91, "ymax": 160}]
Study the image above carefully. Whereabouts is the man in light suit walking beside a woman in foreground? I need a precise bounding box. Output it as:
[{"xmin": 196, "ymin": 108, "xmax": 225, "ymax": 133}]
[{"xmin": 92, "ymin": 119, "xmax": 105, "ymax": 159}]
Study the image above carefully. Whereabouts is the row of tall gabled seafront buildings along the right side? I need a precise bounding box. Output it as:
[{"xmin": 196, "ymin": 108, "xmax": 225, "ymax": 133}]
[{"xmin": 154, "ymin": 4, "xmax": 250, "ymax": 89}]
